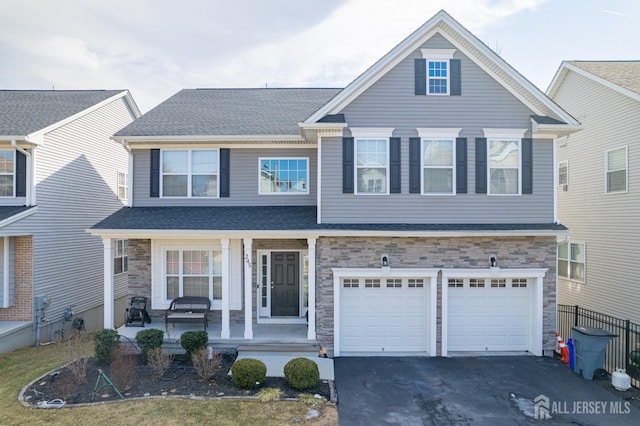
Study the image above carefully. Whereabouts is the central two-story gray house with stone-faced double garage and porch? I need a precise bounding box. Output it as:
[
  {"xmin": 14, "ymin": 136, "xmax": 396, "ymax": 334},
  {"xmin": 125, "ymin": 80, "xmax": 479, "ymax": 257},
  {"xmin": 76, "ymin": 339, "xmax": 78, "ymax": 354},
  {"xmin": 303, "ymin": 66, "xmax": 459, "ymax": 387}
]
[{"xmin": 92, "ymin": 11, "xmax": 579, "ymax": 356}]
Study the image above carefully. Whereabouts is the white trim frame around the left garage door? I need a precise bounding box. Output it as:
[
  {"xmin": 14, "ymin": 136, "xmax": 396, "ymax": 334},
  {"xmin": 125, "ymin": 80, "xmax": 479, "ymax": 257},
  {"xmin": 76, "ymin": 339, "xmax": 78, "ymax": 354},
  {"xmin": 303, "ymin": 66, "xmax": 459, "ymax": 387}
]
[{"xmin": 331, "ymin": 267, "xmax": 439, "ymax": 356}]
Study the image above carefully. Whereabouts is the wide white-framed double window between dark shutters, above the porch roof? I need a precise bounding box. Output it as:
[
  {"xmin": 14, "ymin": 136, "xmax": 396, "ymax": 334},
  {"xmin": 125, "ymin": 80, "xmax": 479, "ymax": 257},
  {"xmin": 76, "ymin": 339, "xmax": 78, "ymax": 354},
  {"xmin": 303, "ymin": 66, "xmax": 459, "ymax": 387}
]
[{"xmin": 161, "ymin": 149, "xmax": 219, "ymax": 198}]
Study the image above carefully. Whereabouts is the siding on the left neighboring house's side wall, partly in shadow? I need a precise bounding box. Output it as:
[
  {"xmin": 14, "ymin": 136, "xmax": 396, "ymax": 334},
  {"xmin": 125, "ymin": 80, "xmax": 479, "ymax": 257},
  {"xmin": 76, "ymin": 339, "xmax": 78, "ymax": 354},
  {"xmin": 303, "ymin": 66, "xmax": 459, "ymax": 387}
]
[{"xmin": 3, "ymin": 98, "xmax": 133, "ymax": 319}]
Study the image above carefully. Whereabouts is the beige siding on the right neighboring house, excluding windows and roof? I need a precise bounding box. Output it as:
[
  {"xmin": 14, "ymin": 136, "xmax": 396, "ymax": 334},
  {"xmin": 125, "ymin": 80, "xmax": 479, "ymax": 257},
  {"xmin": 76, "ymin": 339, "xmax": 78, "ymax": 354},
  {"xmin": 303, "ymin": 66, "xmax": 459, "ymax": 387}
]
[{"xmin": 555, "ymin": 72, "xmax": 640, "ymax": 323}]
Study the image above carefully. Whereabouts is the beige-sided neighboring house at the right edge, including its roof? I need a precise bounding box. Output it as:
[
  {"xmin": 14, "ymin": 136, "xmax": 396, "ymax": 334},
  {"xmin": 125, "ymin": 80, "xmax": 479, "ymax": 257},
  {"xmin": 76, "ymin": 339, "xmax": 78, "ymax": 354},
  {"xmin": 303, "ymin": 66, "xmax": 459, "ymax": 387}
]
[{"xmin": 548, "ymin": 61, "xmax": 640, "ymax": 323}]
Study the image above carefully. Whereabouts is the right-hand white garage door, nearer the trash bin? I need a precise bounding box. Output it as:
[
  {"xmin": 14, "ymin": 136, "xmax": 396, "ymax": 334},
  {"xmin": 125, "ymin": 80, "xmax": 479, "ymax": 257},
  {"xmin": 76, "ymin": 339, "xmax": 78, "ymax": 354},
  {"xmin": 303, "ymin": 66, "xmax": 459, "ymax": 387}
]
[{"xmin": 447, "ymin": 278, "xmax": 533, "ymax": 352}]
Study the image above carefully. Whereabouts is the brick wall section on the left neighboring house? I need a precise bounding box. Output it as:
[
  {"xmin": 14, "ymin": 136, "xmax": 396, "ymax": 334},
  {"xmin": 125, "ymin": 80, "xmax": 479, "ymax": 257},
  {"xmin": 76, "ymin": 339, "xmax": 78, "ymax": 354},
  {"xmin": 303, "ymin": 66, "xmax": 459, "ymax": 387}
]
[{"xmin": 0, "ymin": 235, "xmax": 33, "ymax": 321}]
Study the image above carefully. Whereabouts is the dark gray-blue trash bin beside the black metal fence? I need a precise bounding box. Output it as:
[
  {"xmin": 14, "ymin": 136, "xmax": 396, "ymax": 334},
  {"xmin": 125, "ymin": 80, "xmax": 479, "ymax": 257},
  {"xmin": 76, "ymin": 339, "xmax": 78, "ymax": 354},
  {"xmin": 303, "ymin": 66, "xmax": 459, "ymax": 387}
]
[{"xmin": 571, "ymin": 327, "xmax": 618, "ymax": 380}]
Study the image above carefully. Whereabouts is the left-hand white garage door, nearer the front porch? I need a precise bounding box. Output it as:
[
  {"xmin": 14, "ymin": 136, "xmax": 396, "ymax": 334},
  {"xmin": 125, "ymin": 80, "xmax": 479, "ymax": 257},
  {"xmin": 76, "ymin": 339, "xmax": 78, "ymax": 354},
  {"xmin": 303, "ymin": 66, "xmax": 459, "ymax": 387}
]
[{"xmin": 340, "ymin": 278, "xmax": 429, "ymax": 353}]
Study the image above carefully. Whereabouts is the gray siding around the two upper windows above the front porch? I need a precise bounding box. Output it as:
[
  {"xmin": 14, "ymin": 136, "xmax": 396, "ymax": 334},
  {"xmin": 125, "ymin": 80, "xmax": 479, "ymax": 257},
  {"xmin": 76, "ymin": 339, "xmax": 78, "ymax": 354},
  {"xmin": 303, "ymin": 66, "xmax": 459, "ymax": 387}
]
[{"xmin": 133, "ymin": 147, "xmax": 316, "ymax": 207}]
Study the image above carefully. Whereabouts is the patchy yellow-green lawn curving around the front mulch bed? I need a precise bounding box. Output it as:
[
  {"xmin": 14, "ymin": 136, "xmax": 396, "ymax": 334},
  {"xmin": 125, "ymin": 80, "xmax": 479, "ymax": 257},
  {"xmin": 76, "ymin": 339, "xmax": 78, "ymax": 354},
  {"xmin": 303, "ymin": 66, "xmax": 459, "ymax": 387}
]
[{"xmin": 0, "ymin": 339, "xmax": 338, "ymax": 426}]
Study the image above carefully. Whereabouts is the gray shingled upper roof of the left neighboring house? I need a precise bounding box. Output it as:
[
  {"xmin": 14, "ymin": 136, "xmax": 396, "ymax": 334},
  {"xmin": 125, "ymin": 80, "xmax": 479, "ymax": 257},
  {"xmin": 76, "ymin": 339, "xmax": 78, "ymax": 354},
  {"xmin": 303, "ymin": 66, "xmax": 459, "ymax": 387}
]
[{"xmin": 0, "ymin": 90, "xmax": 123, "ymax": 136}]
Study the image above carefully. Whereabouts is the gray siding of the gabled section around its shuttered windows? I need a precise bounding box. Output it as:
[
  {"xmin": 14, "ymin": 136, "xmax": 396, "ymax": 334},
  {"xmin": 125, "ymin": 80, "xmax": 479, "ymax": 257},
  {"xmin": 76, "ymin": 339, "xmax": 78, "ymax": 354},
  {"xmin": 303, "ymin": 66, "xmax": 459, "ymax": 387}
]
[{"xmin": 320, "ymin": 35, "xmax": 554, "ymax": 223}]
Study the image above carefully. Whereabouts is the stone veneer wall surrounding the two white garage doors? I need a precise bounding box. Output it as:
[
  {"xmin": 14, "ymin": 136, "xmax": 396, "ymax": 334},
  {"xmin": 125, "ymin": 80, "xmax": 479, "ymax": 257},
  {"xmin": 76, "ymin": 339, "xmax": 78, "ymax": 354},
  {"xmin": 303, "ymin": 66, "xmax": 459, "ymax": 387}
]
[{"xmin": 316, "ymin": 237, "xmax": 556, "ymax": 355}]
